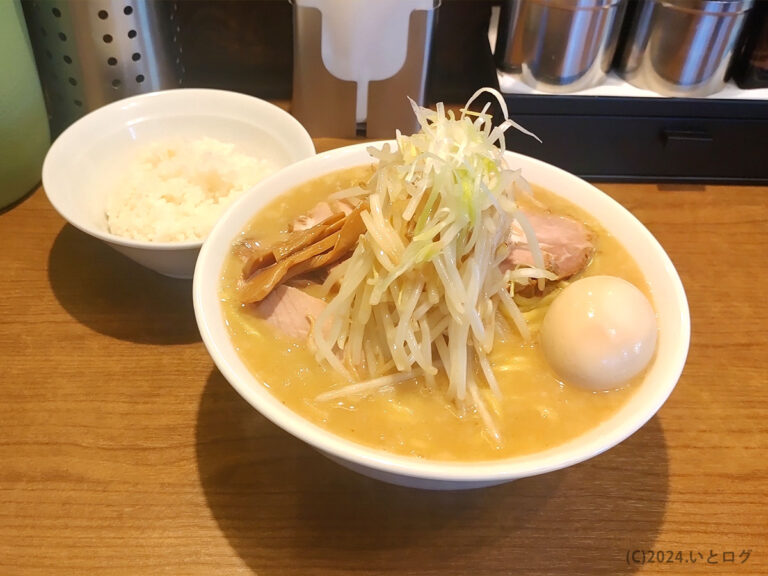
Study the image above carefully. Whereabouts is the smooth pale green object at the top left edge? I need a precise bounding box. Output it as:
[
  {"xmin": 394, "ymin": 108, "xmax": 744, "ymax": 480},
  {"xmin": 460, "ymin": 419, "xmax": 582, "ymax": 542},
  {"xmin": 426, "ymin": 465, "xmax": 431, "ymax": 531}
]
[{"xmin": 0, "ymin": 0, "xmax": 51, "ymax": 209}]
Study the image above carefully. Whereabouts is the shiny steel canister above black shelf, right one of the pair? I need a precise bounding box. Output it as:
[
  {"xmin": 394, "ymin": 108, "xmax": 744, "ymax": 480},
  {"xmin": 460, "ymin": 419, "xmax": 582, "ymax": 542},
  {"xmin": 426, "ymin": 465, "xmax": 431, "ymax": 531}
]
[{"xmin": 618, "ymin": 0, "xmax": 753, "ymax": 97}]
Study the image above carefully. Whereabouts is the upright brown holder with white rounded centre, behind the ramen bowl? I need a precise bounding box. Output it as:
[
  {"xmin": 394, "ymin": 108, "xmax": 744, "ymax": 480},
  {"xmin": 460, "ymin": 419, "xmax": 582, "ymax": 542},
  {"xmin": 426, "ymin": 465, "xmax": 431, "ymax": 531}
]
[{"xmin": 292, "ymin": 0, "xmax": 439, "ymax": 138}]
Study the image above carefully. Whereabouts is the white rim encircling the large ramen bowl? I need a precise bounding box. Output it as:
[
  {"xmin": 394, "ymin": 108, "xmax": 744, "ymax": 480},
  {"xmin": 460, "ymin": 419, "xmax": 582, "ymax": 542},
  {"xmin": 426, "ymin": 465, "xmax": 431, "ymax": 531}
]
[{"xmin": 192, "ymin": 140, "xmax": 690, "ymax": 484}]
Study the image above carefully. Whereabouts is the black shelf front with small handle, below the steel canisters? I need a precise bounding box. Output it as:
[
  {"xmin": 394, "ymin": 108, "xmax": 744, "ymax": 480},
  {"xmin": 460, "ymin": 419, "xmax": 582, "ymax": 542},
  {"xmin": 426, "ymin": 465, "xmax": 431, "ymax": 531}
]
[{"xmin": 505, "ymin": 94, "xmax": 768, "ymax": 184}]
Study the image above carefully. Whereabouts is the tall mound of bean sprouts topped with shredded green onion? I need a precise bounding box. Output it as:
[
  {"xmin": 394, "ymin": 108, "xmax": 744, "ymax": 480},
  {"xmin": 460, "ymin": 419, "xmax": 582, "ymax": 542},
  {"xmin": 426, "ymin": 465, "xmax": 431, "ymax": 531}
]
[{"xmin": 311, "ymin": 88, "xmax": 540, "ymax": 424}]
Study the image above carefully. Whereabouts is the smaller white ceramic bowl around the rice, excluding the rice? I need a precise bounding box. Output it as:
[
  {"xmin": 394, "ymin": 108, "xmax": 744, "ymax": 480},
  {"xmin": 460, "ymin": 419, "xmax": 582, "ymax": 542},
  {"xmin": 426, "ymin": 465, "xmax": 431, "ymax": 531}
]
[{"xmin": 43, "ymin": 88, "xmax": 315, "ymax": 278}]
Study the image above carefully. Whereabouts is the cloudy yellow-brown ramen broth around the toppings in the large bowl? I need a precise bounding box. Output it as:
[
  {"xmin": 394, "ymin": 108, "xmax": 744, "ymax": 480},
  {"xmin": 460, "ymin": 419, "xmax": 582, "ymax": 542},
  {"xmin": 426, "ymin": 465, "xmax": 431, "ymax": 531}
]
[{"xmin": 221, "ymin": 166, "xmax": 652, "ymax": 461}]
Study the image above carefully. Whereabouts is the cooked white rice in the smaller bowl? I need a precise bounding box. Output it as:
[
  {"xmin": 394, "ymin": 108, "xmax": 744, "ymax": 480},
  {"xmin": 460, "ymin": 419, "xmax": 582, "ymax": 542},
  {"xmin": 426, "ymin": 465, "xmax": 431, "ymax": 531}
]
[{"xmin": 106, "ymin": 138, "xmax": 278, "ymax": 242}]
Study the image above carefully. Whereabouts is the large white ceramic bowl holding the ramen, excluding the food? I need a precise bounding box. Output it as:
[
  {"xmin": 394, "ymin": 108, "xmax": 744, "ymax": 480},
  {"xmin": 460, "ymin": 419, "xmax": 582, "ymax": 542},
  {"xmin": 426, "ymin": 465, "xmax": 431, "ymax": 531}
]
[{"xmin": 193, "ymin": 144, "xmax": 690, "ymax": 489}]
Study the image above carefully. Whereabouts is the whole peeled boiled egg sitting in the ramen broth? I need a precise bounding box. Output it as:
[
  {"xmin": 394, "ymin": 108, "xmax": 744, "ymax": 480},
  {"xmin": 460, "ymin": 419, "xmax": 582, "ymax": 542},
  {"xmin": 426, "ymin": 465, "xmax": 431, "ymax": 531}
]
[{"xmin": 540, "ymin": 276, "xmax": 657, "ymax": 390}]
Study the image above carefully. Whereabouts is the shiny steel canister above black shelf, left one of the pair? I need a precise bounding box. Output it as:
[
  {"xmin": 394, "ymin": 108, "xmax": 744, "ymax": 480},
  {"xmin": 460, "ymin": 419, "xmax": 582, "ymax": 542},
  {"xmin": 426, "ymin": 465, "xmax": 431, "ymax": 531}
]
[{"xmin": 495, "ymin": 0, "xmax": 625, "ymax": 92}]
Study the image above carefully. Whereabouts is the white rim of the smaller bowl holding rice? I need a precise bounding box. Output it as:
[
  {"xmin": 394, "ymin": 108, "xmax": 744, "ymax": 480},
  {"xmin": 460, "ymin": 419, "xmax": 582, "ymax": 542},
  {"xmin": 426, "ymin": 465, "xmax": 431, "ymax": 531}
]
[{"xmin": 41, "ymin": 88, "xmax": 315, "ymax": 251}]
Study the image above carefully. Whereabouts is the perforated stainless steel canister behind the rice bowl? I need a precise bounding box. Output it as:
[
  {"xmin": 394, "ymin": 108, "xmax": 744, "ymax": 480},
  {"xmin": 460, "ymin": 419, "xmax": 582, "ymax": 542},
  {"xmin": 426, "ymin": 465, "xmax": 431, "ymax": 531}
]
[{"xmin": 24, "ymin": 0, "xmax": 182, "ymax": 136}]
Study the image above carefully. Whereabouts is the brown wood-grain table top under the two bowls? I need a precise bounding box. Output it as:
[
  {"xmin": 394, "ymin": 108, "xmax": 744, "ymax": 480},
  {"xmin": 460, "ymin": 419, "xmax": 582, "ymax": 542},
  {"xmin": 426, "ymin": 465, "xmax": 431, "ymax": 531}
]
[{"xmin": 0, "ymin": 140, "xmax": 768, "ymax": 576}]
